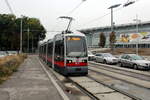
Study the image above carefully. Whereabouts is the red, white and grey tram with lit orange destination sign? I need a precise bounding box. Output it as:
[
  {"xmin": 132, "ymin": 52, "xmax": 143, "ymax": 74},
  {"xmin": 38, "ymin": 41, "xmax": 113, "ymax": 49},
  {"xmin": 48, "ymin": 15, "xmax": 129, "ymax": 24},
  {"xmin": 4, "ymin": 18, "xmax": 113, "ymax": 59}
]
[{"xmin": 39, "ymin": 31, "xmax": 88, "ymax": 76}]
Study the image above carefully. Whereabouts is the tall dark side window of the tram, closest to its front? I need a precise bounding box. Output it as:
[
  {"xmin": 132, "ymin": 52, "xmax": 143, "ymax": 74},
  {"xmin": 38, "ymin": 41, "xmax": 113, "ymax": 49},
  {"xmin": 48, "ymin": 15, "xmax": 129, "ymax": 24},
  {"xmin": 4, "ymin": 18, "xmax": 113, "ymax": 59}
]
[{"xmin": 54, "ymin": 41, "xmax": 64, "ymax": 61}]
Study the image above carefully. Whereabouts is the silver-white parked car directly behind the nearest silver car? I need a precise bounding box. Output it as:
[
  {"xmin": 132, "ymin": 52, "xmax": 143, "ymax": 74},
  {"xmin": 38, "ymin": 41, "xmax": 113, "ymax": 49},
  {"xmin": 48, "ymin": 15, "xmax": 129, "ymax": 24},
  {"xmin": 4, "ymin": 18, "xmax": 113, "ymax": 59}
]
[{"xmin": 95, "ymin": 53, "xmax": 118, "ymax": 64}]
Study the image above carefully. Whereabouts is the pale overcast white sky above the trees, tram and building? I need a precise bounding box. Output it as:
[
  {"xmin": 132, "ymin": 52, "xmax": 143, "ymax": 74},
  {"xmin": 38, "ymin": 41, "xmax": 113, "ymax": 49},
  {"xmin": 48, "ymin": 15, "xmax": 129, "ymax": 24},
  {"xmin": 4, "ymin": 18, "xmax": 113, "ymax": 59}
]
[{"xmin": 0, "ymin": 0, "xmax": 150, "ymax": 38}]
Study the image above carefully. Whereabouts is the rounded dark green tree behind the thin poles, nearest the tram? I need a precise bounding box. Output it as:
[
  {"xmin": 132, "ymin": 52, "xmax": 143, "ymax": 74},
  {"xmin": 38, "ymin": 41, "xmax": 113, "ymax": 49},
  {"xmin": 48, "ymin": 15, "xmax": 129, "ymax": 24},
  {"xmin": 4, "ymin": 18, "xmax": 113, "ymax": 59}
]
[{"xmin": 16, "ymin": 16, "xmax": 46, "ymax": 52}]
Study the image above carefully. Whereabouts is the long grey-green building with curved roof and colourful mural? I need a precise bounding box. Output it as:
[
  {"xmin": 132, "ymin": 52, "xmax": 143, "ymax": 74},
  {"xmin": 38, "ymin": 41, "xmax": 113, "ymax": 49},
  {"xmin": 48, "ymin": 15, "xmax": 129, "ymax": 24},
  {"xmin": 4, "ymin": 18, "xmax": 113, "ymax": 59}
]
[{"xmin": 79, "ymin": 21, "xmax": 150, "ymax": 47}]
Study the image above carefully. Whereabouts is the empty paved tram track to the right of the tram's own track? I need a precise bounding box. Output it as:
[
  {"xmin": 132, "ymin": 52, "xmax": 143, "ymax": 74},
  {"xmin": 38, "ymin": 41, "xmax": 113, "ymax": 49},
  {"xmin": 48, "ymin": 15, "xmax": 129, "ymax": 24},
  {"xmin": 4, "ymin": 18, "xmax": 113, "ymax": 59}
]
[{"xmin": 89, "ymin": 66, "xmax": 150, "ymax": 100}]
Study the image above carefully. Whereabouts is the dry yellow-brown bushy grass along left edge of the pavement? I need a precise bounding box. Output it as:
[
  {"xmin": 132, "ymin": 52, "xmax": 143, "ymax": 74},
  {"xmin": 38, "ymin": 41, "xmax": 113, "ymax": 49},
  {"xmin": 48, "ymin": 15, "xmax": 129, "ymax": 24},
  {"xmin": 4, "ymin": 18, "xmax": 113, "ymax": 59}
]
[{"xmin": 0, "ymin": 54, "xmax": 27, "ymax": 83}]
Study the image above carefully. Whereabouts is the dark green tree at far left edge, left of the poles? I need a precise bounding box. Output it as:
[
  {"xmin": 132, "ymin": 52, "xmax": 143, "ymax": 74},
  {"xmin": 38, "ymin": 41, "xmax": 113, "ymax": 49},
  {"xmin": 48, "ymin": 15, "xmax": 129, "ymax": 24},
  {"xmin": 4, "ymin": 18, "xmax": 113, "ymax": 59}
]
[{"xmin": 0, "ymin": 14, "xmax": 17, "ymax": 50}]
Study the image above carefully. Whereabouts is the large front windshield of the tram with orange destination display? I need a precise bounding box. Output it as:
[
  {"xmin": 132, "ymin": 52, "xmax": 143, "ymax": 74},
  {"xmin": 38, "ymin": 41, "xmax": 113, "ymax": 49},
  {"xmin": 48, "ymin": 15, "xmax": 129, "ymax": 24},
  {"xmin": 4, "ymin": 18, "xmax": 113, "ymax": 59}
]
[{"xmin": 66, "ymin": 36, "xmax": 87, "ymax": 57}]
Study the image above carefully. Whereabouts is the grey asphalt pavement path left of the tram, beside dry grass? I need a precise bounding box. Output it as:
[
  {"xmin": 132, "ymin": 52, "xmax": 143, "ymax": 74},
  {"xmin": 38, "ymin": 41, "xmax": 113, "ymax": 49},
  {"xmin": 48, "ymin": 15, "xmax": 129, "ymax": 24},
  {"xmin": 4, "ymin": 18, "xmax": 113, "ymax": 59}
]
[{"xmin": 0, "ymin": 55, "xmax": 62, "ymax": 100}]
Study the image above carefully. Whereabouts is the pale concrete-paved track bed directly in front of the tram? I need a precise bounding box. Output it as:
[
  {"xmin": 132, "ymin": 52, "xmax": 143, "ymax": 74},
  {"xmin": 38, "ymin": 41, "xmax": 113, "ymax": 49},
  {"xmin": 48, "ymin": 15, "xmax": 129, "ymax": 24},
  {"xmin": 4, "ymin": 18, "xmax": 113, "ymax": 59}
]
[{"xmin": 68, "ymin": 76, "xmax": 136, "ymax": 100}]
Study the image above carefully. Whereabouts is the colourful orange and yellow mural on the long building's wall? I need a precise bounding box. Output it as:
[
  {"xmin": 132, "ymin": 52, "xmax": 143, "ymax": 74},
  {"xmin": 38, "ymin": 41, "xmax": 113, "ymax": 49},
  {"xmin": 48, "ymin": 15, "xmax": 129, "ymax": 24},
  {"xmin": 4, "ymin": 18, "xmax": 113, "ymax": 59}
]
[{"xmin": 117, "ymin": 32, "xmax": 150, "ymax": 43}]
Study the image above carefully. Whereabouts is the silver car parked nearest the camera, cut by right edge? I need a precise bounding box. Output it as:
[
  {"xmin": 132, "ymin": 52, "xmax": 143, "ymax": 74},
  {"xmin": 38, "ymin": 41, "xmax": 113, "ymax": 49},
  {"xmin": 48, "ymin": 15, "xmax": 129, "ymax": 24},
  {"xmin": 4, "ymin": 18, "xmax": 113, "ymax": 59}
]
[{"xmin": 118, "ymin": 54, "xmax": 150, "ymax": 70}]
